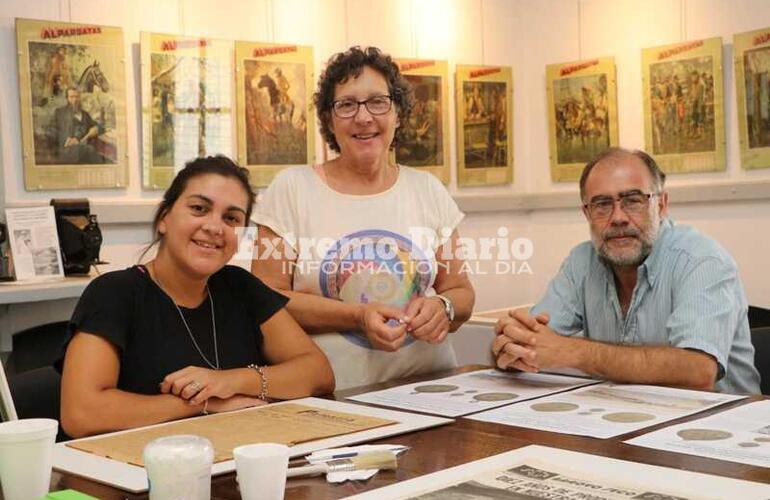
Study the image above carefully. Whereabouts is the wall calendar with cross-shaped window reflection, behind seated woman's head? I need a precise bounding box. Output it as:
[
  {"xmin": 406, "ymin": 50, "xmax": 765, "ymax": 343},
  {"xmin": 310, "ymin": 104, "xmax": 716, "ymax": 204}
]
[{"xmin": 140, "ymin": 32, "xmax": 235, "ymax": 189}]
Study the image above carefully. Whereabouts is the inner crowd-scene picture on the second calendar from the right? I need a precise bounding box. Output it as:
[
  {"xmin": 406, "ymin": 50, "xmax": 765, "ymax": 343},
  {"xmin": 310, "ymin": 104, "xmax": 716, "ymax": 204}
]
[{"xmin": 649, "ymin": 56, "xmax": 716, "ymax": 155}]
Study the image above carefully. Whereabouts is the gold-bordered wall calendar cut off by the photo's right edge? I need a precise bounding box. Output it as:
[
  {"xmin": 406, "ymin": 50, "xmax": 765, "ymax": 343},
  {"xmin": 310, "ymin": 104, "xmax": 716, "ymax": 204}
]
[{"xmin": 733, "ymin": 28, "xmax": 770, "ymax": 169}]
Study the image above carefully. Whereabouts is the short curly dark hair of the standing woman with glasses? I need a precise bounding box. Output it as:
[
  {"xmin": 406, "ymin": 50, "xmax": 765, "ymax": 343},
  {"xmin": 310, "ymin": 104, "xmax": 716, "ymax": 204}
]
[{"xmin": 313, "ymin": 46, "xmax": 412, "ymax": 153}]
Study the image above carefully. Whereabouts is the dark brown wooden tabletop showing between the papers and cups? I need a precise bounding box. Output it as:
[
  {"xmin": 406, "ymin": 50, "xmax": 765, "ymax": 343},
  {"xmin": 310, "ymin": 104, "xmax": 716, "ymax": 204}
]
[{"xmin": 51, "ymin": 365, "xmax": 770, "ymax": 500}]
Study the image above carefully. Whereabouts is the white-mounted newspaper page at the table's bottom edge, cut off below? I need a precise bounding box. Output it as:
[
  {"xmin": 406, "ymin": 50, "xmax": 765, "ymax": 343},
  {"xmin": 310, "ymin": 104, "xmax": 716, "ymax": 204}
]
[{"xmin": 349, "ymin": 446, "xmax": 770, "ymax": 500}]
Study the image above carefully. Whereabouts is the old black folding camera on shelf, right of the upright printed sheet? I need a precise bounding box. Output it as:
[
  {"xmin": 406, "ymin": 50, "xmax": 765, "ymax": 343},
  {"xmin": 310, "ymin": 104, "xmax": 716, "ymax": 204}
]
[{"xmin": 51, "ymin": 199, "xmax": 102, "ymax": 275}]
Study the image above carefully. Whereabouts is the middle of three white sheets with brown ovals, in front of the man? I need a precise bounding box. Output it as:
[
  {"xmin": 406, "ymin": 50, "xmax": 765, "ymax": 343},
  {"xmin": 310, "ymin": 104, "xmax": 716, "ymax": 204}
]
[{"xmin": 468, "ymin": 382, "xmax": 745, "ymax": 438}]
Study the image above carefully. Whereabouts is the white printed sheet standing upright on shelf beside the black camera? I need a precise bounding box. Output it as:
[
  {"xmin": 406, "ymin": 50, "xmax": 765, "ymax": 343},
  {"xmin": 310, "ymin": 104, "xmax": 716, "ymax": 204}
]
[{"xmin": 5, "ymin": 206, "xmax": 64, "ymax": 281}]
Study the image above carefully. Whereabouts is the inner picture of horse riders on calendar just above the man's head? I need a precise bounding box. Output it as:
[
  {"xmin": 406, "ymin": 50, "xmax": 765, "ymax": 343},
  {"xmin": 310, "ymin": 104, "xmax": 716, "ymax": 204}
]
[{"xmin": 553, "ymin": 74, "xmax": 610, "ymax": 164}]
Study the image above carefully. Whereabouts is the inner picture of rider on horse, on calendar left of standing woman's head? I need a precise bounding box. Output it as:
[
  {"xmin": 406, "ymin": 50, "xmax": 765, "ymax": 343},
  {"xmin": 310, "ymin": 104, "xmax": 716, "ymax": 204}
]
[{"xmin": 242, "ymin": 59, "xmax": 308, "ymax": 165}]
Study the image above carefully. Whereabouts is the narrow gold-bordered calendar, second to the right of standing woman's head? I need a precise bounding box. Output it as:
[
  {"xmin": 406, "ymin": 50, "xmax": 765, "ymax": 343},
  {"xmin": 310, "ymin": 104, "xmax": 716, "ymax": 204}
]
[{"xmin": 455, "ymin": 64, "xmax": 513, "ymax": 186}]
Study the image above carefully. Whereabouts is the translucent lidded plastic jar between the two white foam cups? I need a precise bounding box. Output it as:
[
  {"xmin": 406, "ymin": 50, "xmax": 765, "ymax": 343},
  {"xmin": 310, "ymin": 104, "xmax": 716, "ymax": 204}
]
[{"xmin": 142, "ymin": 434, "xmax": 214, "ymax": 500}]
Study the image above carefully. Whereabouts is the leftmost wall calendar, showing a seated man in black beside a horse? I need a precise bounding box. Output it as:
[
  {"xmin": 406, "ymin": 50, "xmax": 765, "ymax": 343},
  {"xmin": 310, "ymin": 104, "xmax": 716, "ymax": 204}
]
[{"xmin": 16, "ymin": 18, "xmax": 128, "ymax": 191}]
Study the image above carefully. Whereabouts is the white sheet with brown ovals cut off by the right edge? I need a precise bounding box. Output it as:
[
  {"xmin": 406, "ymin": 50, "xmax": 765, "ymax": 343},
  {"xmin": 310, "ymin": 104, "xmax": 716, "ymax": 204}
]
[{"xmin": 626, "ymin": 401, "xmax": 770, "ymax": 467}]
